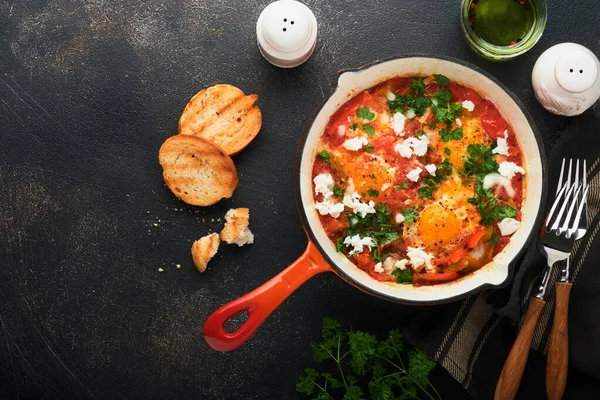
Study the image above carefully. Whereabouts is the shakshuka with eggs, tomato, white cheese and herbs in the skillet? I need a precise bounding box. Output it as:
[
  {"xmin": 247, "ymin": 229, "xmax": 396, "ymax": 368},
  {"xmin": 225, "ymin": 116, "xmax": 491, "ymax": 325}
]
[{"xmin": 312, "ymin": 75, "xmax": 525, "ymax": 285}]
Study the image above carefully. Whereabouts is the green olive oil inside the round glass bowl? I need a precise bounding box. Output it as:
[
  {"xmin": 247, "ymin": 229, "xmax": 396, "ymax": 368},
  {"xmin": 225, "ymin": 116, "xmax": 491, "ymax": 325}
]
[{"xmin": 469, "ymin": 0, "xmax": 534, "ymax": 46}]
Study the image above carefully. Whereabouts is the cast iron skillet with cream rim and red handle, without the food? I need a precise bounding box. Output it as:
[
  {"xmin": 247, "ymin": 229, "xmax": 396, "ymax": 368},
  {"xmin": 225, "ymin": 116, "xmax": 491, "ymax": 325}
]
[{"xmin": 203, "ymin": 54, "xmax": 546, "ymax": 351}]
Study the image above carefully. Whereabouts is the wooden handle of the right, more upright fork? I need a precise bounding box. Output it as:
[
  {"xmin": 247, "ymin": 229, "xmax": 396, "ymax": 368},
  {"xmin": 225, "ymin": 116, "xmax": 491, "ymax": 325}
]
[{"xmin": 546, "ymin": 282, "xmax": 573, "ymax": 400}]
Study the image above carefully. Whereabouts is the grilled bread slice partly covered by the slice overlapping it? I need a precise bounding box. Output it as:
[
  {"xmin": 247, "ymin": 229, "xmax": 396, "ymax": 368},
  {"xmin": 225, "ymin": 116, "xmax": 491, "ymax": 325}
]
[{"xmin": 179, "ymin": 84, "xmax": 262, "ymax": 155}]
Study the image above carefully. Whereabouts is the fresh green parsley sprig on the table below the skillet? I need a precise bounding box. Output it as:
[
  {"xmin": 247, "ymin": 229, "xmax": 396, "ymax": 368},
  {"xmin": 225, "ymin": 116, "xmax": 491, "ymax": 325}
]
[{"xmin": 296, "ymin": 318, "xmax": 441, "ymax": 400}]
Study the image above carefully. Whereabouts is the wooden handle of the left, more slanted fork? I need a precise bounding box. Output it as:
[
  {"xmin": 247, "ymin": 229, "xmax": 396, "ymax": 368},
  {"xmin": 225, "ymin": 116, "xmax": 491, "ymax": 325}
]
[{"xmin": 494, "ymin": 297, "xmax": 546, "ymax": 400}]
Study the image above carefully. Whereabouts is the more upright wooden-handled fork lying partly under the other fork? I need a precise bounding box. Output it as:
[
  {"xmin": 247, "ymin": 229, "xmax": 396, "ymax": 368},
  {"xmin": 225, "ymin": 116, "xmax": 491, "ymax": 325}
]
[{"xmin": 546, "ymin": 159, "xmax": 588, "ymax": 400}]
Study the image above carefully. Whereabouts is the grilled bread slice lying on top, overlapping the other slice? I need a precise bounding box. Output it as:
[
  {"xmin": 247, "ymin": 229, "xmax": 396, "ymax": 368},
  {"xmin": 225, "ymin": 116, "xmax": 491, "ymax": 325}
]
[{"xmin": 158, "ymin": 135, "xmax": 238, "ymax": 206}]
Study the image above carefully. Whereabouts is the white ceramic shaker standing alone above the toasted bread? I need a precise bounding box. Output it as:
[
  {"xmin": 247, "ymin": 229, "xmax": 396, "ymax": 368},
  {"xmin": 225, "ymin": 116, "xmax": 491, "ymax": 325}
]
[{"xmin": 256, "ymin": 0, "xmax": 317, "ymax": 68}]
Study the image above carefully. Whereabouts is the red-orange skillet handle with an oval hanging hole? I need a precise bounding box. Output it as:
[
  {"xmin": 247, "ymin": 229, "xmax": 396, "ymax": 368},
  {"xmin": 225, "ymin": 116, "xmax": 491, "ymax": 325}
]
[{"xmin": 202, "ymin": 240, "xmax": 333, "ymax": 351}]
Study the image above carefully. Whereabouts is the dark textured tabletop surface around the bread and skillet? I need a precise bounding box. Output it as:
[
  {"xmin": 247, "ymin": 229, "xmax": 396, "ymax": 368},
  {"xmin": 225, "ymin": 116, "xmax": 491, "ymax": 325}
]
[{"xmin": 0, "ymin": 0, "xmax": 600, "ymax": 399}]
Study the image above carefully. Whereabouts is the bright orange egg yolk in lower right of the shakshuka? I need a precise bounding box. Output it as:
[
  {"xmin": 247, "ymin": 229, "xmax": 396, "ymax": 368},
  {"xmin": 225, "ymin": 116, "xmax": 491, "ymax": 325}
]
[{"xmin": 418, "ymin": 204, "xmax": 460, "ymax": 248}]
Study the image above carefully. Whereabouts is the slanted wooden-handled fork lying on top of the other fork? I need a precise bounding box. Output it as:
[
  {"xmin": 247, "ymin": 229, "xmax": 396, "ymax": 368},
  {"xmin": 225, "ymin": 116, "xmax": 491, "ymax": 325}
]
[{"xmin": 494, "ymin": 159, "xmax": 588, "ymax": 400}]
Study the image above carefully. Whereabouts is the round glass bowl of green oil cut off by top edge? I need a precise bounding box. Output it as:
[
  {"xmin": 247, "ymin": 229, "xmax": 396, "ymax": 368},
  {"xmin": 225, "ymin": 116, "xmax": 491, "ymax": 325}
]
[{"xmin": 461, "ymin": 0, "xmax": 547, "ymax": 61}]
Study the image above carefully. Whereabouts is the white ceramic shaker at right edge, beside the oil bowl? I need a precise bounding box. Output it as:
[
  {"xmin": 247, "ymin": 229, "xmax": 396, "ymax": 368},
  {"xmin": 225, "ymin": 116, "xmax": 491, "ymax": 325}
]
[{"xmin": 531, "ymin": 43, "xmax": 600, "ymax": 116}]
